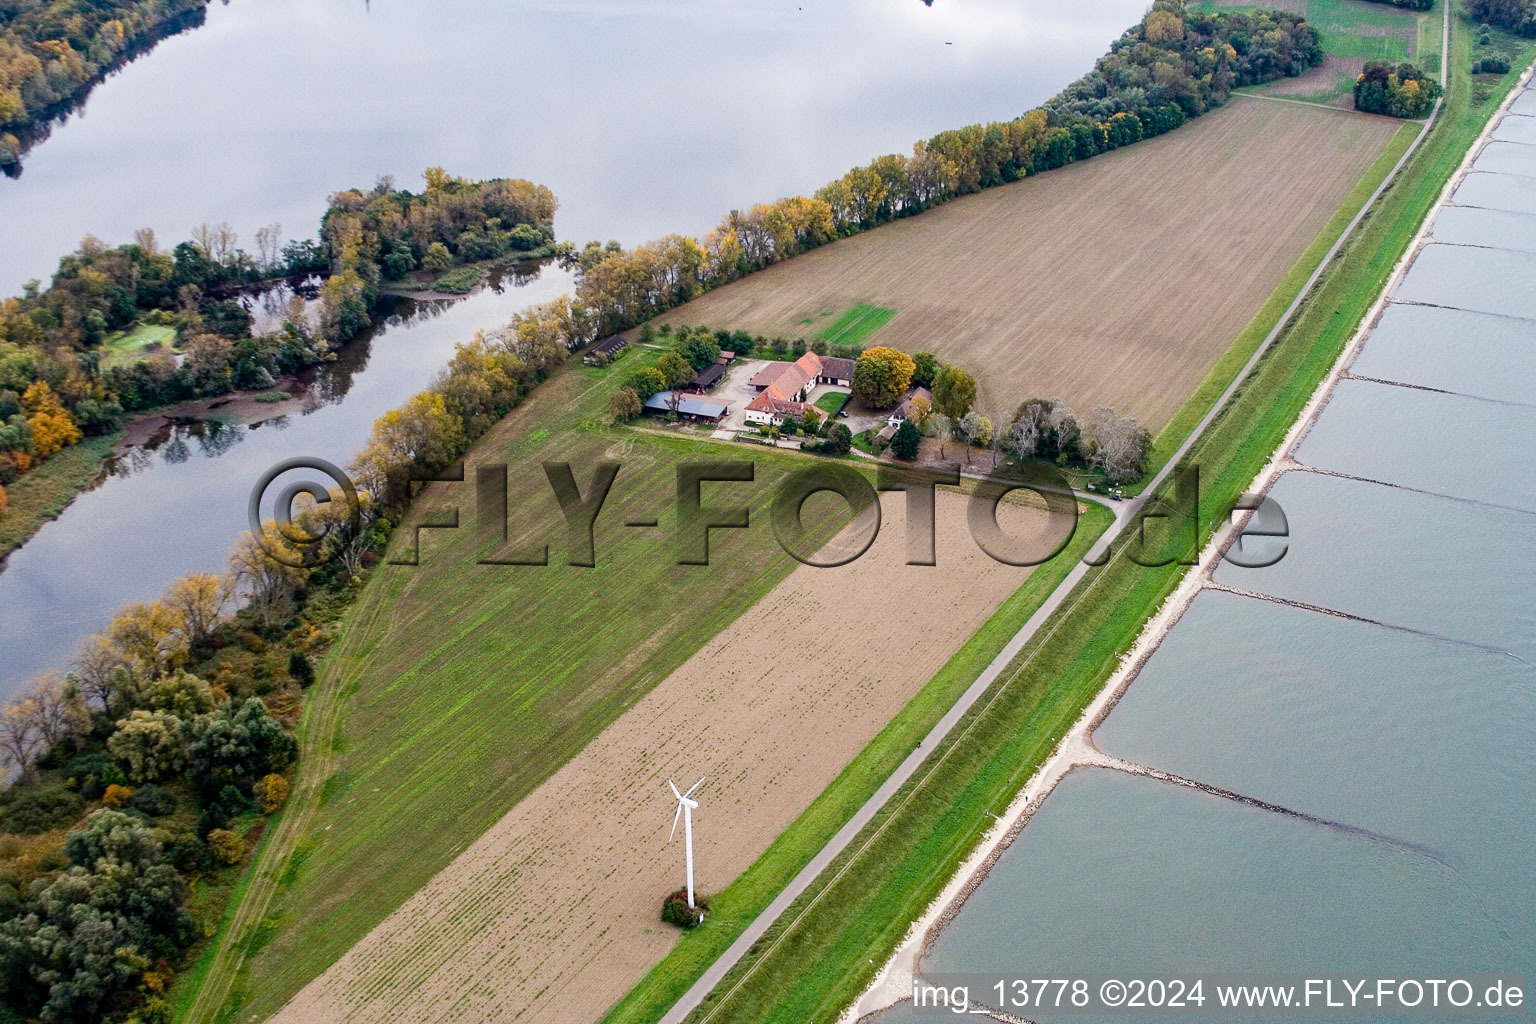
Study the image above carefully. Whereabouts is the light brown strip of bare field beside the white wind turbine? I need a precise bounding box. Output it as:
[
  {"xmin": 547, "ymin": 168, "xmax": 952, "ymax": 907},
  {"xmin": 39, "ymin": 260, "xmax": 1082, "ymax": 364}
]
[{"xmin": 275, "ymin": 493, "xmax": 1046, "ymax": 1024}]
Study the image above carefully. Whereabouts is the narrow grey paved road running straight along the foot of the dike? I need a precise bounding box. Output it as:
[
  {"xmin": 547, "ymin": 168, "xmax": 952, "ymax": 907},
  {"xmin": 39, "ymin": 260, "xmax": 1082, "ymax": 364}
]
[{"xmin": 660, "ymin": 62, "xmax": 1450, "ymax": 1024}]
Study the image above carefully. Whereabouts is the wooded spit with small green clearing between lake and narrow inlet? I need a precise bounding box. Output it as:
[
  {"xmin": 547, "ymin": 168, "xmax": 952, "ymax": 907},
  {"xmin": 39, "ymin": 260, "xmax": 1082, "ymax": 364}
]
[{"xmin": 0, "ymin": 167, "xmax": 554, "ymax": 514}]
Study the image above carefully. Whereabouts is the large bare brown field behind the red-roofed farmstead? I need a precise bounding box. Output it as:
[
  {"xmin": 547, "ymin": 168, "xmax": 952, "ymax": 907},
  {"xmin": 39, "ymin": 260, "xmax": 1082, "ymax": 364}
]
[{"xmin": 662, "ymin": 95, "xmax": 1399, "ymax": 431}]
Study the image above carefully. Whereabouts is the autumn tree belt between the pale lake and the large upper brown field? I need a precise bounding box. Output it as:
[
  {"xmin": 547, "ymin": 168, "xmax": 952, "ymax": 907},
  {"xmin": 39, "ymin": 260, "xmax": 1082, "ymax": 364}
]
[{"xmin": 509, "ymin": 0, "xmax": 1322, "ymax": 347}]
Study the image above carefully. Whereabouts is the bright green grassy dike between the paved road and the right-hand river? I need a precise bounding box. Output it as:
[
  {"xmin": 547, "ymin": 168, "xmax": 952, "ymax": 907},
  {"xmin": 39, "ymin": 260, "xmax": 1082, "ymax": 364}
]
[{"xmin": 607, "ymin": 15, "xmax": 1533, "ymax": 1024}]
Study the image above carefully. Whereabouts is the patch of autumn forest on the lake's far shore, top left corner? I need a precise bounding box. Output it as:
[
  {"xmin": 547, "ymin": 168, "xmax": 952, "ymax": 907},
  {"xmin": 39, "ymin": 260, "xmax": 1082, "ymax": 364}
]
[{"xmin": 0, "ymin": 0, "xmax": 207, "ymax": 172}]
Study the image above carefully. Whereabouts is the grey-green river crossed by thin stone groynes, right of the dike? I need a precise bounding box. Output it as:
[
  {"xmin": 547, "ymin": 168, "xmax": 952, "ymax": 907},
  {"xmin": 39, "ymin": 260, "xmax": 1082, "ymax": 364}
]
[{"xmin": 880, "ymin": 78, "xmax": 1536, "ymax": 1024}]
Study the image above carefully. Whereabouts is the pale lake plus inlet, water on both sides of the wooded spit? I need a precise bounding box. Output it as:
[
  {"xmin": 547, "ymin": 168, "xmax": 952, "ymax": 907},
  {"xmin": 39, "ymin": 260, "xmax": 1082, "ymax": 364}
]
[{"xmin": 0, "ymin": 0, "xmax": 1147, "ymax": 695}]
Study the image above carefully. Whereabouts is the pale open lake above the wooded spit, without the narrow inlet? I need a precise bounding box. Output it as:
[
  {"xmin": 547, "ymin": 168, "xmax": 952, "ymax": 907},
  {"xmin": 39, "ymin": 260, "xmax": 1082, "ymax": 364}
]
[{"xmin": 0, "ymin": 0, "xmax": 1147, "ymax": 293}]
